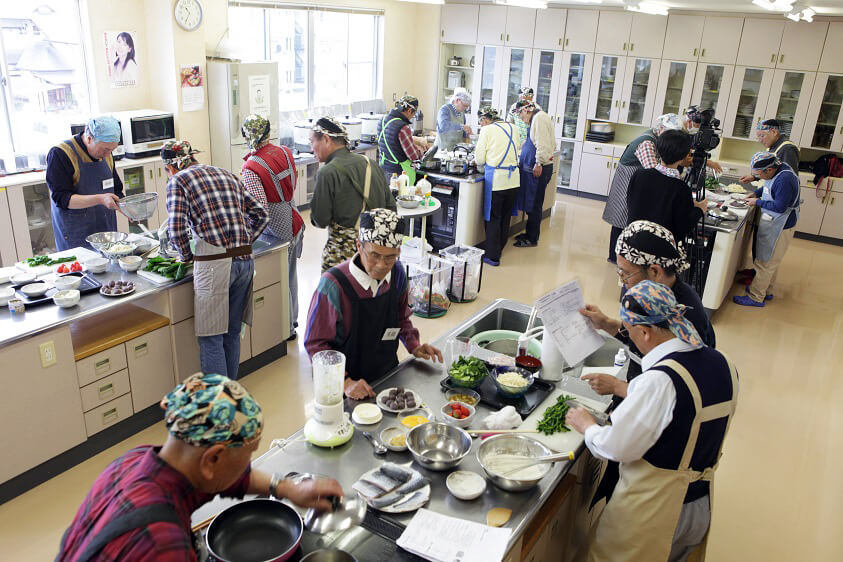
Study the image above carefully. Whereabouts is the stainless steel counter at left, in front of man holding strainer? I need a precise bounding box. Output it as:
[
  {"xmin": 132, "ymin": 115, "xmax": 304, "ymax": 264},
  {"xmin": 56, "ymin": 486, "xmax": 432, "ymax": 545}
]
[{"xmin": 0, "ymin": 234, "xmax": 288, "ymax": 347}]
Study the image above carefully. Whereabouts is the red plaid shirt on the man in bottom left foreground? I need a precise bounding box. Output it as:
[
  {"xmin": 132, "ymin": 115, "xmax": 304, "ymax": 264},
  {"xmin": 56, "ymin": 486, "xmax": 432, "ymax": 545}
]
[{"xmin": 58, "ymin": 445, "xmax": 250, "ymax": 562}]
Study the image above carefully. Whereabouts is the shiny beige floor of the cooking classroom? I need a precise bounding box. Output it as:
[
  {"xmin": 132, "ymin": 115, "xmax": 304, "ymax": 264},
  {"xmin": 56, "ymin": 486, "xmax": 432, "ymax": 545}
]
[{"xmin": 0, "ymin": 191, "xmax": 843, "ymax": 561}]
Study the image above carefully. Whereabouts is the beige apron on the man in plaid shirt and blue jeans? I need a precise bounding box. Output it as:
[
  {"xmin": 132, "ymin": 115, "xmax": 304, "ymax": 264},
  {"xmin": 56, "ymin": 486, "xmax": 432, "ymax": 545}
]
[{"xmin": 193, "ymin": 234, "xmax": 252, "ymax": 336}]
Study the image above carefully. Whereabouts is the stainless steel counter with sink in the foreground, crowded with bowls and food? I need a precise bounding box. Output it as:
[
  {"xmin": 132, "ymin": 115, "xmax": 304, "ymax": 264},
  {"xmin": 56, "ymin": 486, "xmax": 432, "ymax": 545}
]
[{"xmin": 193, "ymin": 299, "xmax": 620, "ymax": 547}]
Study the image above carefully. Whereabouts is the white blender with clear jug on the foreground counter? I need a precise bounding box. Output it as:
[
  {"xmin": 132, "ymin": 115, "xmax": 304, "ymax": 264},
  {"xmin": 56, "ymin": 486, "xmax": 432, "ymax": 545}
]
[{"xmin": 304, "ymin": 350, "xmax": 354, "ymax": 447}]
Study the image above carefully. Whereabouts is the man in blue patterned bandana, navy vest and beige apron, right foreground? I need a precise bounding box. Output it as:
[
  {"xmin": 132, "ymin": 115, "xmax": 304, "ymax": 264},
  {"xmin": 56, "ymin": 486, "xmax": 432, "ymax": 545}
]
[{"xmin": 566, "ymin": 281, "xmax": 738, "ymax": 562}]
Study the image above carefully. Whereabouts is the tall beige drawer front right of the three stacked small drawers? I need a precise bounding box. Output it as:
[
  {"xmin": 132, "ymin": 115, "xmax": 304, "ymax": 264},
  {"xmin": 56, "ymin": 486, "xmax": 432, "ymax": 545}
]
[{"xmin": 126, "ymin": 326, "xmax": 176, "ymax": 412}]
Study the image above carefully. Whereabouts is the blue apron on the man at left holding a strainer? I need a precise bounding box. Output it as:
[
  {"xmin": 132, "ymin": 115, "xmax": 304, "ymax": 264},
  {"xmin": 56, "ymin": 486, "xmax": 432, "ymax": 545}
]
[{"xmin": 50, "ymin": 140, "xmax": 117, "ymax": 251}]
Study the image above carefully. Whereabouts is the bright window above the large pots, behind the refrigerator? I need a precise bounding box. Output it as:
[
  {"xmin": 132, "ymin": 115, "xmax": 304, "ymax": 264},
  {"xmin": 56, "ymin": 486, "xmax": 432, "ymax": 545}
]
[{"xmin": 228, "ymin": 2, "xmax": 383, "ymax": 111}]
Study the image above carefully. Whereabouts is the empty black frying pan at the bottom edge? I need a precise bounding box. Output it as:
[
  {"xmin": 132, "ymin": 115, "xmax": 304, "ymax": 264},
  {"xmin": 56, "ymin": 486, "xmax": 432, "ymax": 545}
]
[{"xmin": 205, "ymin": 498, "xmax": 304, "ymax": 562}]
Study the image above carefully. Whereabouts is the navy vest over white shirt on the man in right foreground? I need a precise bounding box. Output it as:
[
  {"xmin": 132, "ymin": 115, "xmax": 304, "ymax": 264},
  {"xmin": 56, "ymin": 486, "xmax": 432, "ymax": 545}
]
[{"xmin": 644, "ymin": 347, "xmax": 737, "ymax": 503}]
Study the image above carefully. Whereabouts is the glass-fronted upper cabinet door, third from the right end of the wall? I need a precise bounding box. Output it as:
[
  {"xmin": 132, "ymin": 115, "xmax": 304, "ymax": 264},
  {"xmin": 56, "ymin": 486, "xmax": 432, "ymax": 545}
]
[{"xmin": 723, "ymin": 66, "xmax": 774, "ymax": 140}]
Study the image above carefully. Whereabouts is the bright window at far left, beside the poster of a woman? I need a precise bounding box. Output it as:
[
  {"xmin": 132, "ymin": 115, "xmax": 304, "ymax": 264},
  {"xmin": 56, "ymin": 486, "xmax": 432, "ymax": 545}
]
[{"xmin": 0, "ymin": 0, "xmax": 90, "ymax": 172}]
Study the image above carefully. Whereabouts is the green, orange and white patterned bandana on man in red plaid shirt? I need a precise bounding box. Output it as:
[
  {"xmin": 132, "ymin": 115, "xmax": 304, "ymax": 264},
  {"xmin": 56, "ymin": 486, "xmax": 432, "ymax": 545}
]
[{"xmin": 161, "ymin": 374, "xmax": 263, "ymax": 447}]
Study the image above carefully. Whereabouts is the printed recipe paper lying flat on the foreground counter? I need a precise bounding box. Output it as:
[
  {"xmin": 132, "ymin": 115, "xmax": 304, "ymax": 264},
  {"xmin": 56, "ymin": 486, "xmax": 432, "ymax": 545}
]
[{"xmin": 396, "ymin": 508, "xmax": 512, "ymax": 562}]
